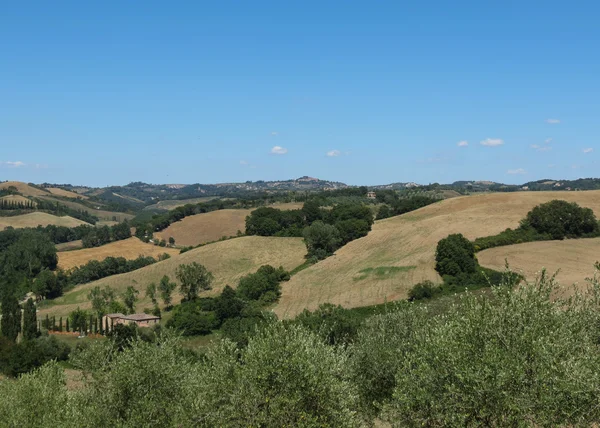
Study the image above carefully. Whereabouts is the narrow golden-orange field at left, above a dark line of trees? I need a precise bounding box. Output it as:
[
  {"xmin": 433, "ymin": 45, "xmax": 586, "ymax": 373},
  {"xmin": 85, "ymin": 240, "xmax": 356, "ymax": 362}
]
[{"xmin": 58, "ymin": 237, "xmax": 179, "ymax": 270}]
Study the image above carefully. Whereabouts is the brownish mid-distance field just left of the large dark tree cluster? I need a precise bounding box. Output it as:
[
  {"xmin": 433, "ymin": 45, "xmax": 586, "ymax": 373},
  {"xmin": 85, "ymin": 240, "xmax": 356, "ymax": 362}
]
[{"xmin": 154, "ymin": 203, "xmax": 302, "ymax": 246}]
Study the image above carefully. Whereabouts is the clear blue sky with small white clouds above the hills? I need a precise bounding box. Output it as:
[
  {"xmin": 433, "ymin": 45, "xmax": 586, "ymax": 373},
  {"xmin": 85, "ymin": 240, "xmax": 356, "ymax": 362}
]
[{"xmin": 0, "ymin": 1, "xmax": 600, "ymax": 186}]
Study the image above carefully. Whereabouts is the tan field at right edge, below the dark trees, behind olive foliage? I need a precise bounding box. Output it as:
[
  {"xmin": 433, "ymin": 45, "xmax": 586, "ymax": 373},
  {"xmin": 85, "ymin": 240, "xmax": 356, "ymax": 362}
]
[{"xmin": 477, "ymin": 238, "xmax": 600, "ymax": 287}]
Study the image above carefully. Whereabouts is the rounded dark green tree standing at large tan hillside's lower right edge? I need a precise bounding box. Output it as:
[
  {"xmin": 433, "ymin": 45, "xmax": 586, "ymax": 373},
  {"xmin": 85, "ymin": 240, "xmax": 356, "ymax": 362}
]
[{"xmin": 435, "ymin": 233, "xmax": 478, "ymax": 276}]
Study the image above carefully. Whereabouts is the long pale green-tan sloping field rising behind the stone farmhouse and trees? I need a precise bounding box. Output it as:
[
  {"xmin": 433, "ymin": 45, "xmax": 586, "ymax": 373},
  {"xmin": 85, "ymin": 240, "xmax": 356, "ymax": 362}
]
[{"xmin": 38, "ymin": 236, "xmax": 306, "ymax": 317}]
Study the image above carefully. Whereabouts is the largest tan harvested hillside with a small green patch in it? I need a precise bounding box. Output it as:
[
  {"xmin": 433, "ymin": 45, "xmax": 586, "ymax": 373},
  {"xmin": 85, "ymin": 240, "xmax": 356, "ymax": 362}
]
[{"xmin": 275, "ymin": 191, "xmax": 600, "ymax": 318}]
